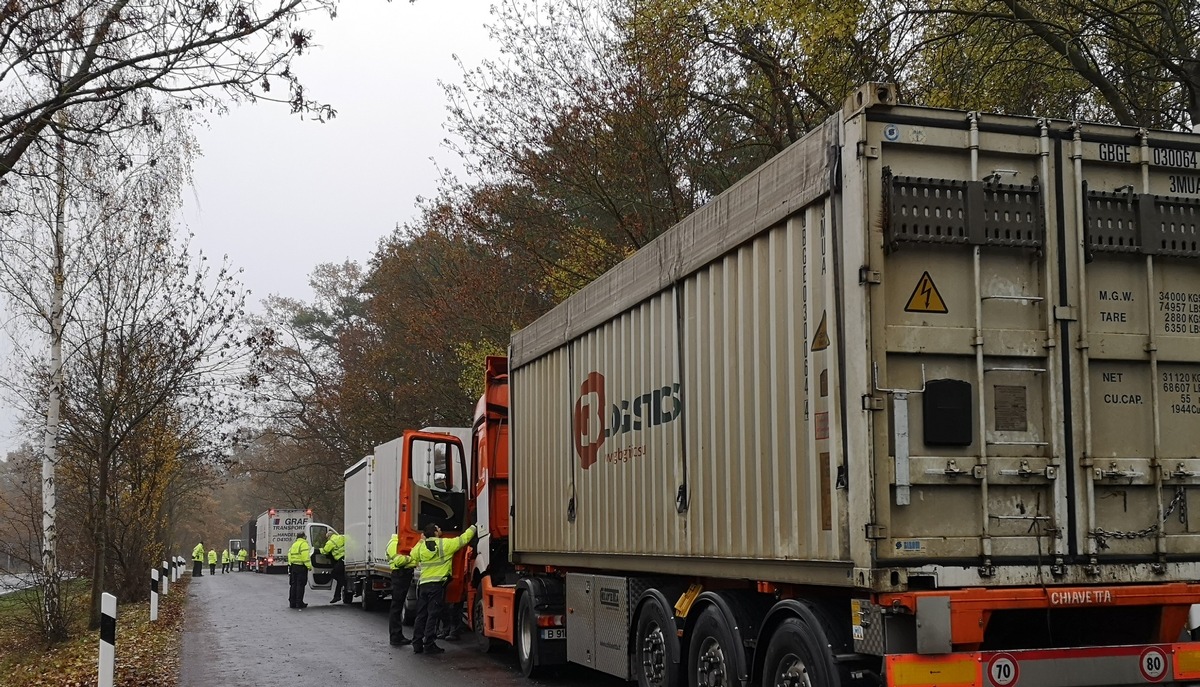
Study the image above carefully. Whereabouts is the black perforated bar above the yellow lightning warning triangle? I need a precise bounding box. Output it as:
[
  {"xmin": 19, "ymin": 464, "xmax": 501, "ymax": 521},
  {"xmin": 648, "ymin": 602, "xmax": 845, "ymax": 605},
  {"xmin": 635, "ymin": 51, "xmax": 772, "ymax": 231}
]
[{"xmin": 883, "ymin": 169, "xmax": 1045, "ymax": 251}]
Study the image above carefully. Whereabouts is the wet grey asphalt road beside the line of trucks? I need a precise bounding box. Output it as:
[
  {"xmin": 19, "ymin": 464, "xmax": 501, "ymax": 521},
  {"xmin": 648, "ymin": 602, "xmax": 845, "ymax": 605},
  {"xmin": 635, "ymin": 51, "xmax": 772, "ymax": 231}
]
[{"xmin": 179, "ymin": 570, "xmax": 625, "ymax": 687}]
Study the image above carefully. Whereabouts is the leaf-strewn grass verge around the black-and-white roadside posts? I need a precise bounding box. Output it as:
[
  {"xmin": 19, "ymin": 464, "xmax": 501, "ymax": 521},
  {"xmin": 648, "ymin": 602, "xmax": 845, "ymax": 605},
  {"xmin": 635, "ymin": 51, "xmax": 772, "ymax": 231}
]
[{"xmin": 0, "ymin": 577, "xmax": 191, "ymax": 687}]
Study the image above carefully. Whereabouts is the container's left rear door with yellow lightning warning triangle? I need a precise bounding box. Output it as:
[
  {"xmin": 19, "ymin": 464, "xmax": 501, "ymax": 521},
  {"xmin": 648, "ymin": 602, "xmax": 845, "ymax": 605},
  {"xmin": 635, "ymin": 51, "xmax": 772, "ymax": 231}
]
[{"xmin": 868, "ymin": 115, "xmax": 1067, "ymax": 569}]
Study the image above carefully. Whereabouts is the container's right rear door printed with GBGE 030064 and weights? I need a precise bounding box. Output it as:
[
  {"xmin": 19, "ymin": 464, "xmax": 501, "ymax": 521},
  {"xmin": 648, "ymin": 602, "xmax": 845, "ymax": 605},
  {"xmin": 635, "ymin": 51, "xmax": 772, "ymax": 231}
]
[{"xmin": 1072, "ymin": 127, "xmax": 1200, "ymax": 564}]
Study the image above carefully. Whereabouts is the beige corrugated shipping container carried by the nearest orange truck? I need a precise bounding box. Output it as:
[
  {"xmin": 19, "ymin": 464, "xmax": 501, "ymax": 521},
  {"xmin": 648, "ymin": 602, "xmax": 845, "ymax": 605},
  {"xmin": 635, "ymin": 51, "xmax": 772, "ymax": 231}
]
[{"xmin": 510, "ymin": 85, "xmax": 1200, "ymax": 590}]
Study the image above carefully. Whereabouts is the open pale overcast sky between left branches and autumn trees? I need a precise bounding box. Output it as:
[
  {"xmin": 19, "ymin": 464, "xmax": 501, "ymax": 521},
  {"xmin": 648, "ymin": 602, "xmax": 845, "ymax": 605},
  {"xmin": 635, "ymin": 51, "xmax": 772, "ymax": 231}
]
[{"xmin": 182, "ymin": 0, "xmax": 497, "ymax": 309}]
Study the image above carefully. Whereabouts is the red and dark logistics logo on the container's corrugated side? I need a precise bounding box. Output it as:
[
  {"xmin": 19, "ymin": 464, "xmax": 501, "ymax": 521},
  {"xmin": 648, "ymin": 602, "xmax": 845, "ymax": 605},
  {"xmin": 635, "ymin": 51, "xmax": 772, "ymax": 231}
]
[{"xmin": 575, "ymin": 372, "xmax": 683, "ymax": 470}]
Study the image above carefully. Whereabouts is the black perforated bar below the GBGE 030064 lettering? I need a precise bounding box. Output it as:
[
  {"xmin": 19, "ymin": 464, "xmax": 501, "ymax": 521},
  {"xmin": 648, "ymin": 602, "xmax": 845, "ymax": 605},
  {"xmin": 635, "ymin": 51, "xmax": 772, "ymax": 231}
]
[{"xmin": 1084, "ymin": 185, "xmax": 1200, "ymax": 259}]
